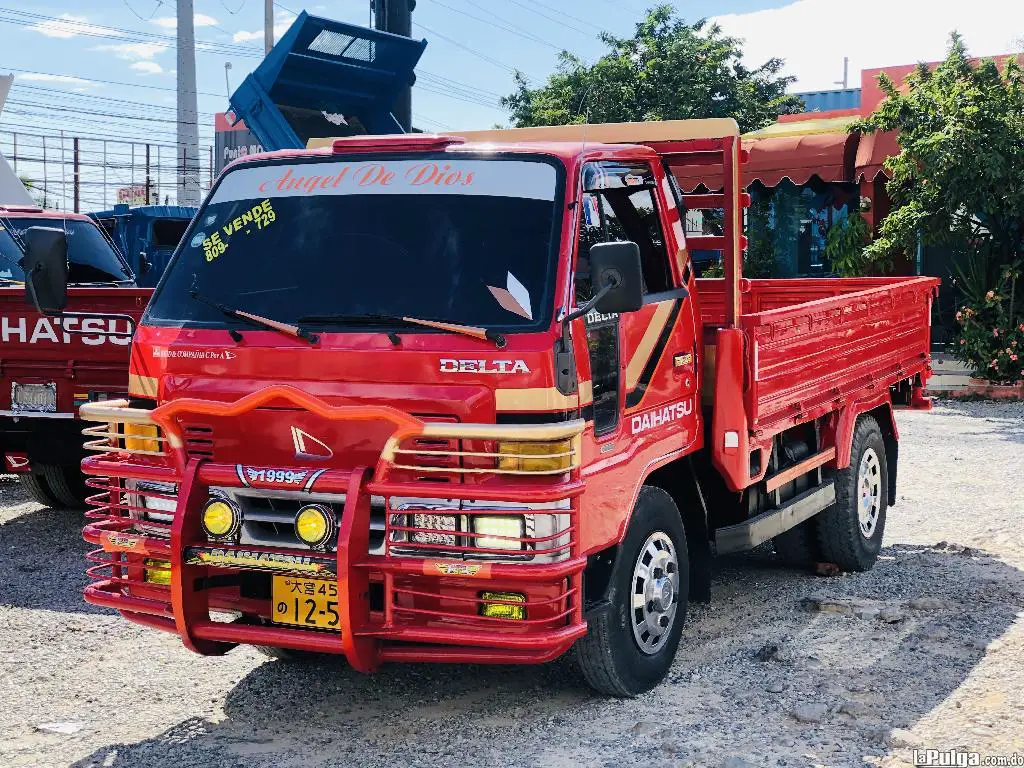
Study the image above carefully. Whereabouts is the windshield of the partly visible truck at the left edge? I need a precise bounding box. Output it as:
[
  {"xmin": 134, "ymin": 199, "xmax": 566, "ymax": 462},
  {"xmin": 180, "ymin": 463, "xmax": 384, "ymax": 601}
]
[{"xmin": 0, "ymin": 217, "xmax": 133, "ymax": 285}]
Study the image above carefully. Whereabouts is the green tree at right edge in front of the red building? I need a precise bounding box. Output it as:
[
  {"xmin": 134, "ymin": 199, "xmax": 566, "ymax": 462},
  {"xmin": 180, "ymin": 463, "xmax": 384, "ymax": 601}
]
[{"xmin": 851, "ymin": 33, "xmax": 1024, "ymax": 280}]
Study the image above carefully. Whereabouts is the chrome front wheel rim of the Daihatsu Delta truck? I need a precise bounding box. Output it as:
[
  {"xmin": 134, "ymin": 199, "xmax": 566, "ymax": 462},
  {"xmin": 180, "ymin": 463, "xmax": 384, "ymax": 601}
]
[{"xmin": 631, "ymin": 530, "xmax": 679, "ymax": 655}]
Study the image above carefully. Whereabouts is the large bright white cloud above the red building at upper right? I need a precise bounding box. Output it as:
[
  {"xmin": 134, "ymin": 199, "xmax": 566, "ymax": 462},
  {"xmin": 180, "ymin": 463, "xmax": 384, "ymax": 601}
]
[{"xmin": 714, "ymin": 0, "xmax": 1024, "ymax": 91}]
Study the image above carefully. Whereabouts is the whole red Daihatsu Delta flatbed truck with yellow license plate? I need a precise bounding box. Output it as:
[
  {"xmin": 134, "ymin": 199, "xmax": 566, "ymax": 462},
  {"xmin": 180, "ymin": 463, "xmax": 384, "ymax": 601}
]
[{"xmin": 32, "ymin": 120, "xmax": 938, "ymax": 696}]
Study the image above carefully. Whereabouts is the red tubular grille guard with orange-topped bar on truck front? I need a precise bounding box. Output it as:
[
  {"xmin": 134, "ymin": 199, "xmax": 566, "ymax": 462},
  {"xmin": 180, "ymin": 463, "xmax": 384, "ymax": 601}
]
[{"xmin": 77, "ymin": 386, "xmax": 587, "ymax": 672}]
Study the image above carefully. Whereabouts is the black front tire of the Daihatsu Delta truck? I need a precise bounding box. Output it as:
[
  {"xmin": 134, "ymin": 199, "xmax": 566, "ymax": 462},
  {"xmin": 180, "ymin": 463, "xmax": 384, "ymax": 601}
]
[{"xmin": 575, "ymin": 485, "xmax": 690, "ymax": 698}]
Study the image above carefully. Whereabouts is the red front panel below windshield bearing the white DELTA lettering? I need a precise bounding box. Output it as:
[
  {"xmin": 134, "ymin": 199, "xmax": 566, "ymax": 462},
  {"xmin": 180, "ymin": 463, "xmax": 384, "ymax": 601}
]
[{"xmin": 130, "ymin": 327, "xmax": 564, "ymax": 467}]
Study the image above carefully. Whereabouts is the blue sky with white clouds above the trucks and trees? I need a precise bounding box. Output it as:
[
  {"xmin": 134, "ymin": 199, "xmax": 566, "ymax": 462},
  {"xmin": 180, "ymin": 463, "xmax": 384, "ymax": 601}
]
[{"xmin": 0, "ymin": 0, "xmax": 1024, "ymax": 207}]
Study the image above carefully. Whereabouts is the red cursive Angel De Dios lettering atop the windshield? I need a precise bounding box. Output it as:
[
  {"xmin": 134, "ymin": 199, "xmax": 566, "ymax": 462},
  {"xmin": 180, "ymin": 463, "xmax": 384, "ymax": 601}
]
[{"xmin": 257, "ymin": 163, "xmax": 473, "ymax": 195}]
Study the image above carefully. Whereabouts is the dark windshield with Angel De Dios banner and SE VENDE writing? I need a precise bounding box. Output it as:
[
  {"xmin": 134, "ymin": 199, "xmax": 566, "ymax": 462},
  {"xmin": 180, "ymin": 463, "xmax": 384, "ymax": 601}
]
[{"xmin": 145, "ymin": 155, "xmax": 563, "ymax": 332}]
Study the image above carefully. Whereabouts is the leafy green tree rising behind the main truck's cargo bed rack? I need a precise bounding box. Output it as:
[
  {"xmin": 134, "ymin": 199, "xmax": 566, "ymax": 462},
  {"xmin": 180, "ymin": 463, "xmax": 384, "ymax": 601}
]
[{"xmin": 502, "ymin": 5, "xmax": 803, "ymax": 131}]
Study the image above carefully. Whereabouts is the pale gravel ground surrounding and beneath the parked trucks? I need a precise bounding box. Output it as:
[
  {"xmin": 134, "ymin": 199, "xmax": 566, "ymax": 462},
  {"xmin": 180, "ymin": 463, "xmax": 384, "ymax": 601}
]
[{"xmin": 0, "ymin": 403, "xmax": 1024, "ymax": 768}]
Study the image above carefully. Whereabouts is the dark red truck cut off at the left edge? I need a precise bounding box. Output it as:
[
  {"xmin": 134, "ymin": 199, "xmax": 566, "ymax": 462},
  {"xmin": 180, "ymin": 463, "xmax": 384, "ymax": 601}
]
[{"xmin": 0, "ymin": 206, "xmax": 153, "ymax": 507}]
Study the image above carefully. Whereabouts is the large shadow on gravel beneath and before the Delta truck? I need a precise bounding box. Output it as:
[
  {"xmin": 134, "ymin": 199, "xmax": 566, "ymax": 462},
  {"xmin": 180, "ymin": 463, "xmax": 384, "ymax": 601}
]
[{"xmin": 75, "ymin": 545, "xmax": 1024, "ymax": 768}]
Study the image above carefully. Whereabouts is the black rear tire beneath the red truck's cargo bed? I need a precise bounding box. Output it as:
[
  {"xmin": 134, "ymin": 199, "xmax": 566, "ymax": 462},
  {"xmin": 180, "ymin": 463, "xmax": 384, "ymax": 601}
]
[{"xmin": 817, "ymin": 416, "xmax": 889, "ymax": 571}]
